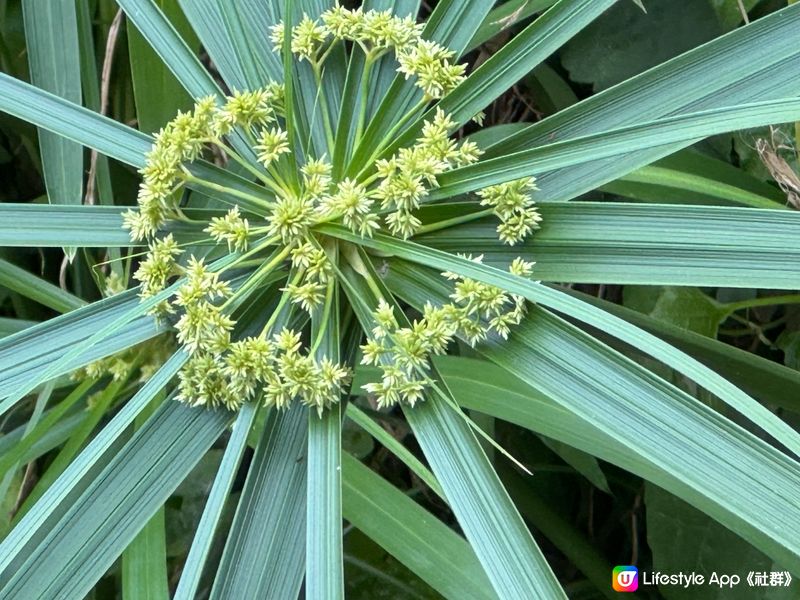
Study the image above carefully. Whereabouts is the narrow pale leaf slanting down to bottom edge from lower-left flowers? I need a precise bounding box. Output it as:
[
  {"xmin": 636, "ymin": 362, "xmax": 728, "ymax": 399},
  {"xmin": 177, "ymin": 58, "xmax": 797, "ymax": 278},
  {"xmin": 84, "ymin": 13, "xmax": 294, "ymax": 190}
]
[{"xmin": 174, "ymin": 402, "xmax": 258, "ymax": 600}]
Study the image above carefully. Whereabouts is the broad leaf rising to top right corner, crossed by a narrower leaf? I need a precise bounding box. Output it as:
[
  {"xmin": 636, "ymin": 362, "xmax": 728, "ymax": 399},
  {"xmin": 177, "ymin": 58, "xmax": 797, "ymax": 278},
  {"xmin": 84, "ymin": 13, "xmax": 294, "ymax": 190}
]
[{"xmin": 487, "ymin": 1, "xmax": 800, "ymax": 200}]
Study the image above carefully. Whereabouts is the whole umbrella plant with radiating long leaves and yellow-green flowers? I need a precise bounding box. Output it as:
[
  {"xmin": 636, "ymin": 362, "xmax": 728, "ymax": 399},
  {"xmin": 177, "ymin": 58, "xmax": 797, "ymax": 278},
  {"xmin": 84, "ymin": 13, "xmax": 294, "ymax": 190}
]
[{"xmin": 0, "ymin": 0, "xmax": 800, "ymax": 599}]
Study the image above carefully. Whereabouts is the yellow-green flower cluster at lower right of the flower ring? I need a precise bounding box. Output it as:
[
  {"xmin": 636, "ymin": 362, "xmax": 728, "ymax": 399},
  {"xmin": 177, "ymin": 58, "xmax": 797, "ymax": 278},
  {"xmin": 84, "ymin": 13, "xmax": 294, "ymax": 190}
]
[{"xmin": 361, "ymin": 256, "xmax": 533, "ymax": 407}]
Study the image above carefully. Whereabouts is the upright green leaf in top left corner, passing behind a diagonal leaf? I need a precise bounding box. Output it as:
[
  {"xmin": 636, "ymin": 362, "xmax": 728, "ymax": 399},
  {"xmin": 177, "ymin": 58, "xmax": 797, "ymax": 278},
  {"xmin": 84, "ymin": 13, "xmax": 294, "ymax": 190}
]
[{"xmin": 22, "ymin": 0, "xmax": 83, "ymax": 220}]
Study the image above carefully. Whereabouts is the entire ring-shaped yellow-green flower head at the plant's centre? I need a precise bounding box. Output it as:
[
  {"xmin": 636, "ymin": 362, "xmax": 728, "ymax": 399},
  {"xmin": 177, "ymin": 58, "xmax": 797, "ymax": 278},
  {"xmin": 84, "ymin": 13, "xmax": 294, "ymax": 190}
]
[{"xmin": 115, "ymin": 6, "xmax": 540, "ymax": 411}]
